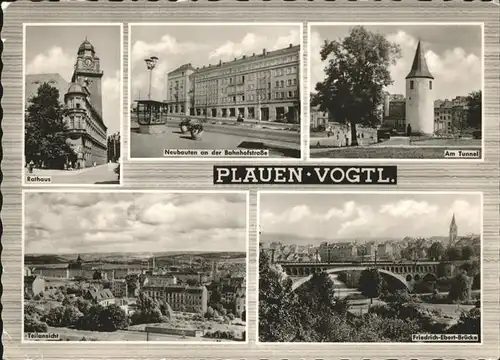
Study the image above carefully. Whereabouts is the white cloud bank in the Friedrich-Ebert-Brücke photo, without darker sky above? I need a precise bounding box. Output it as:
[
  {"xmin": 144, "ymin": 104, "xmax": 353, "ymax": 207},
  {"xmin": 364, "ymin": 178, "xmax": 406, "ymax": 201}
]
[{"xmin": 260, "ymin": 197, "xmax": 481, "ymax": 240}]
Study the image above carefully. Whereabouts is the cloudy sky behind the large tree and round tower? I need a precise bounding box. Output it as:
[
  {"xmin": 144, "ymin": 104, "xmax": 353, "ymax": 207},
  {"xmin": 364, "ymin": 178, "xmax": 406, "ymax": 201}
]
[{"xmin": 310, "ymin": 25, "xmax": 482, "ymax": 99}]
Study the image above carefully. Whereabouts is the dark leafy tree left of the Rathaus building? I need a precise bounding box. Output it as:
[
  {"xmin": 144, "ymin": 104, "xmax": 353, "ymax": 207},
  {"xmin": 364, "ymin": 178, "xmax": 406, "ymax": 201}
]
[{"xmin": 24, "ymin": 83, "xmax": 74, "ymax": 169}]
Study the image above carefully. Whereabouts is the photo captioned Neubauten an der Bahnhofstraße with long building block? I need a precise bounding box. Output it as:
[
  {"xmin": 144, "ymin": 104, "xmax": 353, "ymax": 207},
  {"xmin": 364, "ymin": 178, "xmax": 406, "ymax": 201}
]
[{"xmin": 130, "ymin": 24, "xmax": 301, "ymax": 158}]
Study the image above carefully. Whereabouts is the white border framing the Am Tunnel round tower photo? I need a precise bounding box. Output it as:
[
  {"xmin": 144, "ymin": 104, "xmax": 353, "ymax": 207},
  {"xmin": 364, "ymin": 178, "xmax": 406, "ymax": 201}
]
[{"xmin": 307, "ymin": 21, "xmax": 486, "ymax": 164}]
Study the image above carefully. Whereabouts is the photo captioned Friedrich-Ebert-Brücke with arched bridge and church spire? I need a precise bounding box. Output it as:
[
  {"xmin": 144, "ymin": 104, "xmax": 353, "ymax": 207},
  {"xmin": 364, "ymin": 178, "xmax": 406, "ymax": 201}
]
[{"xmin": 258, "ymin": 191, "xmax": 482, "ymax": 344}]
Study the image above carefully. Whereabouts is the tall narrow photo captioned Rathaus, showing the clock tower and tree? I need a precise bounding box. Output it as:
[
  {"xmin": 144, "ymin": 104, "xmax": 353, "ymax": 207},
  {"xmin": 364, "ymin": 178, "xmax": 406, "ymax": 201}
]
[{"xmin": 23, "ymin": 25, "xmax": 122, "ymax": 185}]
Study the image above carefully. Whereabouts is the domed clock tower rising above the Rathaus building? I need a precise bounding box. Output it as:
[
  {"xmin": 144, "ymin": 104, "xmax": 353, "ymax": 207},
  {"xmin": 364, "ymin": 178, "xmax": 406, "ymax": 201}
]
[{"xmin": 71, "ymin": 38, "xmax": 103, "ymax": 120}]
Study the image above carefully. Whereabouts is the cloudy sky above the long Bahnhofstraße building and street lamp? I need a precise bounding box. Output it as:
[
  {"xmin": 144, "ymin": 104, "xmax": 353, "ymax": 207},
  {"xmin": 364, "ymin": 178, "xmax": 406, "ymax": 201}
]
[{"xmin": 130, "ymin": 25, "xmax": 301, "ymax": 101}]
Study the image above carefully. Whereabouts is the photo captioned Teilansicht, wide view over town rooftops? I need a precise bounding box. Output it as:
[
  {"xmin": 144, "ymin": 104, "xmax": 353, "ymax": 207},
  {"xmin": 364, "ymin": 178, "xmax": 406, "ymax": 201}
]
[{"xmin": 23, "ymin": 191, "xmax": 248, "ymax": 343}]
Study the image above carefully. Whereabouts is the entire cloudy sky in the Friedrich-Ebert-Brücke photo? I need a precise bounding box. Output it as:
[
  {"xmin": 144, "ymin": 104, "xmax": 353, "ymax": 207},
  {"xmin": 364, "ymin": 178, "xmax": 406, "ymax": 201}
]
[{"xmin": 260, "ymin": 193, "xmax": 481, "ymax": 240}]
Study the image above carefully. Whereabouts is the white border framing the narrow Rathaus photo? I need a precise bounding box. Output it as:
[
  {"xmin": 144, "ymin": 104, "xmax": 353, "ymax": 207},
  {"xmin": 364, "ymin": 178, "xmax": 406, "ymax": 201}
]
[{"xmin": 21, "ymin": 22, "xmax": 124, "ymax": 188}]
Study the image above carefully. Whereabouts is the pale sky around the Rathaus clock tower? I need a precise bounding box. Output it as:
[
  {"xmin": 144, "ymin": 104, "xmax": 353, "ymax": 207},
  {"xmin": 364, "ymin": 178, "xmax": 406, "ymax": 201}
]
[{"xmin": 25, "ymin": 25, "xmax": 122, "ymax": 134}]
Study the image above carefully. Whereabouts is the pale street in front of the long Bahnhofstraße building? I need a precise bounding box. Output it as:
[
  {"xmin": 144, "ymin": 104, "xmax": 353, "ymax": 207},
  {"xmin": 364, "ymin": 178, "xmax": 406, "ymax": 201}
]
[{"xmin": 130, "ymin": 124, "xmax": 300, "ymax": 158}]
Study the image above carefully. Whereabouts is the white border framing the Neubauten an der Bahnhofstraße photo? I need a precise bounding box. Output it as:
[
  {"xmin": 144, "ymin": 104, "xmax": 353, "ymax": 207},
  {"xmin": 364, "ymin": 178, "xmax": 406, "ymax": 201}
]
[{"xmin": 127, "ymin": 22, "xmax": 308, "ymax": 163}]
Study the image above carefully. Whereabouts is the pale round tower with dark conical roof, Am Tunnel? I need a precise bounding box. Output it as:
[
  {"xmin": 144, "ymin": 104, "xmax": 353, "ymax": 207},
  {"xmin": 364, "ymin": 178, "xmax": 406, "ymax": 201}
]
[{"xmin": 405, "ymin": 41, "xmax": 434, "ymax": 135}]
